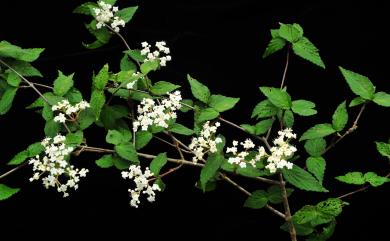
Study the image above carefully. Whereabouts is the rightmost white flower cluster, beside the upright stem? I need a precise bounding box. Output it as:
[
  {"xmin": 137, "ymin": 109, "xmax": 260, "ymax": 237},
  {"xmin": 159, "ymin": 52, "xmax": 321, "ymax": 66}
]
[{"xmin": 265, "ymin": 128, "xmax": 297, "ymax": 173}]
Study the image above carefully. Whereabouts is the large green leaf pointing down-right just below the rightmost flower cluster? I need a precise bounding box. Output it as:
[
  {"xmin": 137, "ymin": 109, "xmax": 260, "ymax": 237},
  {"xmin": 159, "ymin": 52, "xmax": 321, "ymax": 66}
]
[{"xmin": 282, "ymin": 165, "xmax": 328, "ymax": 192}]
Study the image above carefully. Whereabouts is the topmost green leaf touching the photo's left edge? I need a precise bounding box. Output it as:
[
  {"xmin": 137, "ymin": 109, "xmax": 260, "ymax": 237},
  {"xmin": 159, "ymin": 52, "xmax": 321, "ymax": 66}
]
[{"xmin": 0, "ymin": 40, "xmax": 45, "ymax": 62}]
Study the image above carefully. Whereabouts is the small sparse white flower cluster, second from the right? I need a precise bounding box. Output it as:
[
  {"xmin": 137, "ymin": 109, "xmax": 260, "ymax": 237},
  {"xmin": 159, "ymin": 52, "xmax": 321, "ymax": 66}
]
[{"xmin": 226, "ymin": 139, "xmax": 267, "ymax": 168}]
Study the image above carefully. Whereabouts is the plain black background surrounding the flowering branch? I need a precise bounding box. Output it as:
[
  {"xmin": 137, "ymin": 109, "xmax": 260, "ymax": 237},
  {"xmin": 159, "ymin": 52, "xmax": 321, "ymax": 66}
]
[{"xmin": 0, "ymin": 0, "xmax": 390, "ymax": 240}]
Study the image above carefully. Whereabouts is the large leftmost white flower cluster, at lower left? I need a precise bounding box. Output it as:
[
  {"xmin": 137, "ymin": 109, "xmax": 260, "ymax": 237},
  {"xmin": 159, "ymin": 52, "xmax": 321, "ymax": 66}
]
[{"xmin": 29, "ymin": 134, "xmax": 88, "ymax": 197}]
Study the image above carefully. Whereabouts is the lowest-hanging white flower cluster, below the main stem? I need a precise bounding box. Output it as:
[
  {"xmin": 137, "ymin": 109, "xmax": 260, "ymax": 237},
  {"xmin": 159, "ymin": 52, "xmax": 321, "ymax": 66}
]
[{"xmin": 122, "ymin": 165, "xmax": 161, "ymax": 208}]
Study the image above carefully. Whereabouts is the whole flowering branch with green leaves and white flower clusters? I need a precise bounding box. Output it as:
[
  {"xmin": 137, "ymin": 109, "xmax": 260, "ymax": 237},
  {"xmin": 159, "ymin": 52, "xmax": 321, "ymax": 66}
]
[{"xmin": 0, "ymin": 0, "xmax": 390, "ymax": 241}]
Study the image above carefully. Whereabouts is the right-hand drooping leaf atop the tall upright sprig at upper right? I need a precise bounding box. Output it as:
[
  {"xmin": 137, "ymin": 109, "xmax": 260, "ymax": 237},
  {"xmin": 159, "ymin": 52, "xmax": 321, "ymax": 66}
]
[{"xmin": 292, "ymin": 37, "xmax": 325, "ymax": 69}]
